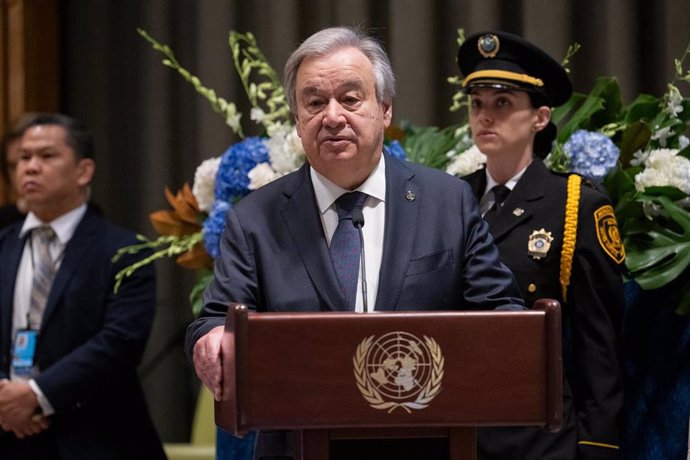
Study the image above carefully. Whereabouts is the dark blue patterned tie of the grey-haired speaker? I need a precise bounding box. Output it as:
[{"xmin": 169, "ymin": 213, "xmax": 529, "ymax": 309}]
[{"xmin": 330, "ymin": 192, "xmax": 367, "ymax": 310}]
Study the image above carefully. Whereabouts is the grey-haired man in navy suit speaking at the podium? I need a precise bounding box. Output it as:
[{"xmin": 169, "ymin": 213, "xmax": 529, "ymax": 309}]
[{"xmin": 187, "ymin": 28, "xmax": 524, "ymax": 459}]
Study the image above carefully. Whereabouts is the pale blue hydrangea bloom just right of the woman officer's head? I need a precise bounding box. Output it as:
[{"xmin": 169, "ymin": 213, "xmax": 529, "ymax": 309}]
[{"xmin": 563, "ymin": 129, "xmax": 620, "ymax": 181}]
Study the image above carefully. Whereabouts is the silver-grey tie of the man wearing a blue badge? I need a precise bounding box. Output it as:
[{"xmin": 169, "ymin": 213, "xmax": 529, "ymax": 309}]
[{"xmin": 29, "ymin": 225, "xmax": 56, "ymax": 330}]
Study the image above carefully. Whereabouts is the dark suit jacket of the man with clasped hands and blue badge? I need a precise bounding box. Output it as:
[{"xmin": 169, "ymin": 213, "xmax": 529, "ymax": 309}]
[{"xmin": 0, "ymin": 209, "xmax": 165, "ymax": 459}]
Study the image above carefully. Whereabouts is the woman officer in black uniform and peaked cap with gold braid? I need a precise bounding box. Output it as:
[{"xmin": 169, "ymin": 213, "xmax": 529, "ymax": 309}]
[{"xmin": 458, "ymin": 32, "xmax": 625, "ymax": 460}]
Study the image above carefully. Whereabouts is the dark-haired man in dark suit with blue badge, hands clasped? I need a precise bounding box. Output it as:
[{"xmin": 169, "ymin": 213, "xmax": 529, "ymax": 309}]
[{"xmin": 0, "ymin": 114, "xmax": 165, "ymax": 459}]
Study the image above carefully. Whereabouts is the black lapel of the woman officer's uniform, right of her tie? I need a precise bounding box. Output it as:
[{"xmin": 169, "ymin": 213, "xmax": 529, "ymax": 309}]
[{"xmin": 490, "ymin": 159, "xmax": 548, "ymax": 241}]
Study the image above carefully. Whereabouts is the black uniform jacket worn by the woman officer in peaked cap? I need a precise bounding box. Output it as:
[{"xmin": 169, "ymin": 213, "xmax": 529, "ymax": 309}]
[{"xmin": 465, "ymin": 159, "xmax": 623, "ymax": 459}]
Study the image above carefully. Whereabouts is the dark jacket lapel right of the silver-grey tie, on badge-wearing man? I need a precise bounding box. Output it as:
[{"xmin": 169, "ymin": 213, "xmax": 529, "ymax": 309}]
[{"xmin": 41, "ymin": 209, "xmax": 96, "ymax": 328}]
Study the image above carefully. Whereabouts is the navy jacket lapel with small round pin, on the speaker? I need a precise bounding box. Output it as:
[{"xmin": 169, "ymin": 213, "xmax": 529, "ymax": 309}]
[{"xmin": 375, "ymin": 156, "xmax": 416, "ymax": 310}]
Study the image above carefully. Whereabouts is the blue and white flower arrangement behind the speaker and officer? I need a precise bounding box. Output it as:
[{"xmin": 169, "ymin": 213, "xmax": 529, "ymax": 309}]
[{"xmin": 116, "ymin": 29, "xmax": 690, "ymax": 314}]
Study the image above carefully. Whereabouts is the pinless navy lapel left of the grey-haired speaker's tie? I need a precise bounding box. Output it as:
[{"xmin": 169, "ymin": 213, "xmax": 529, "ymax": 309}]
[{"xmin": 281, "ymin": 163, "xmax": 347, "ymax": 310}]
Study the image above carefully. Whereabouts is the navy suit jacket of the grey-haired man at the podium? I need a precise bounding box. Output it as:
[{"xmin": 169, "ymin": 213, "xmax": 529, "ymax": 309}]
[{"xmin": 187, "ymin": 156, "xmax": 523, "ymax": 458}]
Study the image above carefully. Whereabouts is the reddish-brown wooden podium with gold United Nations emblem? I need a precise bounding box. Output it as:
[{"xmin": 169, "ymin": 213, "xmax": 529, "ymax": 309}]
[{"xmin": 215, "ymin": 299, "xmax": 562, "ymax": 460}]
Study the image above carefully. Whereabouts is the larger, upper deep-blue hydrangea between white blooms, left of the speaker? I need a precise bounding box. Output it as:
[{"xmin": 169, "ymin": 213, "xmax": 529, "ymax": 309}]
[{"xmin": 215, "ymin": 137, "xmax": 268, "ymax": 202}]
